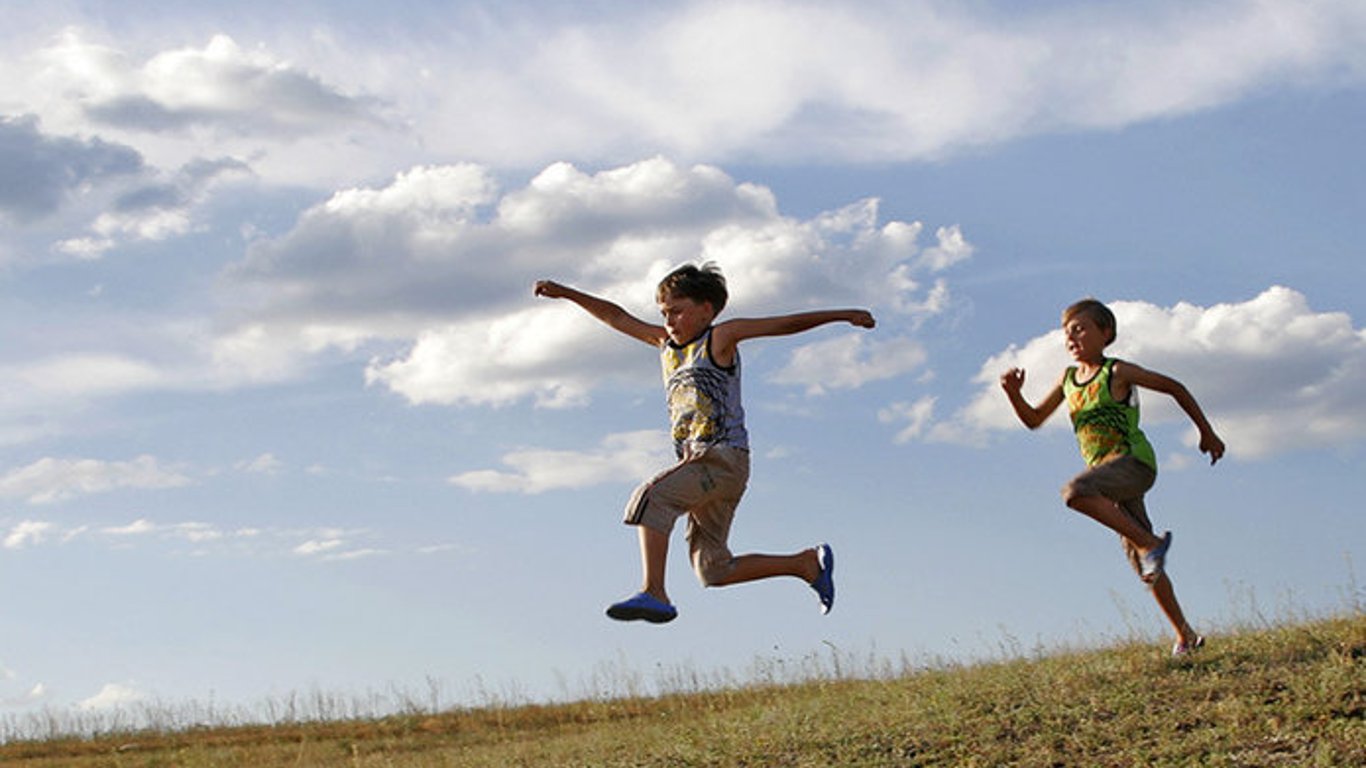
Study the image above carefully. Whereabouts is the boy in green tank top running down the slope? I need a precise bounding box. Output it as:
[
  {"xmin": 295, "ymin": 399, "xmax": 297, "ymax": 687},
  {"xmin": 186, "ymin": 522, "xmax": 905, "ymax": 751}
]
[{"xmin": 1001, "ymin": 299, "xmax": 1224, "ymax": 656}]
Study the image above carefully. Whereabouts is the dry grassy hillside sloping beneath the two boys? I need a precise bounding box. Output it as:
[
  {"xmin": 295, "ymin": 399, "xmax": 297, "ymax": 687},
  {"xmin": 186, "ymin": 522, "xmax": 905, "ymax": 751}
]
[{"xmin": 0, "ymin": 609, "xmax": 1366, "ymax": 768}]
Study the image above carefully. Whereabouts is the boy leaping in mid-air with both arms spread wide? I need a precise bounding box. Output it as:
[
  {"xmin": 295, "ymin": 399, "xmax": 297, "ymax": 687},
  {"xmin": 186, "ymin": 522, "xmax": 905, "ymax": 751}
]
[{"xmin": 535, "ymin": 264, "xmax": 874, "ymax": 623}]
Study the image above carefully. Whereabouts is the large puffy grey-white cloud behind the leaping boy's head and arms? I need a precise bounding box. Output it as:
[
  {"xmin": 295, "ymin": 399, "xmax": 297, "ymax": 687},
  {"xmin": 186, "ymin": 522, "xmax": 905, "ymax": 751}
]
[{"xmin": 217, "ymin": 159, "xmax": 971, "ymax": 406}]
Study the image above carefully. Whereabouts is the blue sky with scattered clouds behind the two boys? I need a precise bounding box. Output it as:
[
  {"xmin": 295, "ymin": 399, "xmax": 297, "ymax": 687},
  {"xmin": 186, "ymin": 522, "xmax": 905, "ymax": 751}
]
[{"xmin": 0, "ymin": 0, "xmax": 1366, "ymax": 720}]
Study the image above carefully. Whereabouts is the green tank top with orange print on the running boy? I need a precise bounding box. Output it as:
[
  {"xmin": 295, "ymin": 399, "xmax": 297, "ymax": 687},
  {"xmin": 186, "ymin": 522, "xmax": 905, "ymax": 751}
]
[{"xmin": 1063, "ymin": 358, "xmax": 1157, "ymax": 471}]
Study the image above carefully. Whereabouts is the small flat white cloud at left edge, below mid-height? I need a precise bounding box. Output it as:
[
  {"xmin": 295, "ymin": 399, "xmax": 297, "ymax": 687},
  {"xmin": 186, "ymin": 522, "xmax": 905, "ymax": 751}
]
[{"xmin": 0, "ymin": 455, "xmax": 190, "ymax": 504}]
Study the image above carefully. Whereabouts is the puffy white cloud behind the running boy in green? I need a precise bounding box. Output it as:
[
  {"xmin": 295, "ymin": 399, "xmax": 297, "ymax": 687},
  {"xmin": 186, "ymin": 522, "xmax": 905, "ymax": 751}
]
[{"xmin": 929, "ymin": 286, "xmax": 1366, "ymax": 459}]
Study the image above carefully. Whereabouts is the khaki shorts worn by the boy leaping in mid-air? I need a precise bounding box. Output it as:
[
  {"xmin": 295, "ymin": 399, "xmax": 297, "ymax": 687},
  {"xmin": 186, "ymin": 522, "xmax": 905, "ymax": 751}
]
[{"xmin": 624, "ymin": 445, "xmax": 750, "ymax": 585}]
